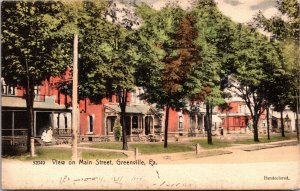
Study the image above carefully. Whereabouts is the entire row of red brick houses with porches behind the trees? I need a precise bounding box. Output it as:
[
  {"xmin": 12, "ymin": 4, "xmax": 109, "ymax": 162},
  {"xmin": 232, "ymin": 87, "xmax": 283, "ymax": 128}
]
[{"xmin": 1, "ymin": 70, "xmax": 282, "ymax": 144}]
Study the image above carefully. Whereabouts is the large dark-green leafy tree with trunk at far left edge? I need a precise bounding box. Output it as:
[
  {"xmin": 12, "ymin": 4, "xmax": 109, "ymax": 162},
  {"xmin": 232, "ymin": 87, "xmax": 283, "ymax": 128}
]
[{"xmin": 1, "ymin": 1, "xmax": 71, "ymax": 154}]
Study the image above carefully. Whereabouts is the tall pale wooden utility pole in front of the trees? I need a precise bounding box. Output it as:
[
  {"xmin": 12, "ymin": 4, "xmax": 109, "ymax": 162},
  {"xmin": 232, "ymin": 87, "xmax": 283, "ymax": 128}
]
[{"xmin": 72, "ymin": 34, "xmax": 78, "ymax": 161}]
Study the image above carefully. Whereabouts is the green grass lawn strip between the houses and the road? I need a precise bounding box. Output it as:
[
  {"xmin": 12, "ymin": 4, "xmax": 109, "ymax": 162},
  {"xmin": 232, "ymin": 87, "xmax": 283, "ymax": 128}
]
[{"xmin": 2, "ymin": 133, "xmax": 296, "ymax": 160}]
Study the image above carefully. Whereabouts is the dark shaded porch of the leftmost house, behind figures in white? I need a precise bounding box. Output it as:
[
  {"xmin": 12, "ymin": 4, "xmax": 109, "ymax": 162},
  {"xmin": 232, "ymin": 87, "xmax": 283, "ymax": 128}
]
[{"xmin": 1, "ymin": 97, "xmax": 71, "ymax": 145}]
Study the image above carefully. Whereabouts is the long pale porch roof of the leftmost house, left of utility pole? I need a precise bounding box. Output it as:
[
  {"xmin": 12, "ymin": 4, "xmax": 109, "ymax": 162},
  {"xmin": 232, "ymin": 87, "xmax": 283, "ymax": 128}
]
[{"xmin": 1, "ymin": 96, "xmax": 66, "ymax": 110}]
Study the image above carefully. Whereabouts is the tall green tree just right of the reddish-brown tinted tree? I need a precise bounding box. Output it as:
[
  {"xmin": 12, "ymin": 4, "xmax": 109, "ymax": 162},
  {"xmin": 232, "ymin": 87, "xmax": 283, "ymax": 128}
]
[{"xmin": 190, "ymin": 0, "xmax": 233, "ymax": 144}]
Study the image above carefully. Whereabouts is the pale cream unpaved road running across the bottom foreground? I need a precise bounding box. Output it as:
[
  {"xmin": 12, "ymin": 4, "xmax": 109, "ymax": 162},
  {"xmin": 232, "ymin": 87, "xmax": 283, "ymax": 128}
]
[{"xmin": 2, "ymin": 145, "xmax": 300, "ymax": 189}]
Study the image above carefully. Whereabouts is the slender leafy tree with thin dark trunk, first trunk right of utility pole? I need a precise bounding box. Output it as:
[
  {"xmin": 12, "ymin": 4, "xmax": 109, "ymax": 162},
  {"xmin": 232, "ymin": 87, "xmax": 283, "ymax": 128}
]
[{"xmin": 107, "ymin": 30, "xmax": 144, "ymax": 150}]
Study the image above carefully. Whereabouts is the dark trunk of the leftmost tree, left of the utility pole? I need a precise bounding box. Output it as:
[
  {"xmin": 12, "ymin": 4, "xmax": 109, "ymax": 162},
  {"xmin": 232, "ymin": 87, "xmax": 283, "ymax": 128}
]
[{"xmin": 26, "ymin": 83, "xmax": 34, "ymax": 157}]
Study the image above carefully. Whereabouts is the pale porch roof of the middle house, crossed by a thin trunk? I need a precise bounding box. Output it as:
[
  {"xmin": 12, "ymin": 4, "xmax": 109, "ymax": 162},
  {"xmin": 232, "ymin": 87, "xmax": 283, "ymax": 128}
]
[{"xmin": 104, "ymin": 104, "xmax": 153, "ymax": 114}]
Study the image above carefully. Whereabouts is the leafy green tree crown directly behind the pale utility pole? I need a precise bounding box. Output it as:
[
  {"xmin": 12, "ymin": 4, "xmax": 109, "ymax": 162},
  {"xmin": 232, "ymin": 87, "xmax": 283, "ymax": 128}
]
[{"xmin": 53, "ymin": 1, "xmax": 115, "ymax": 103}]
